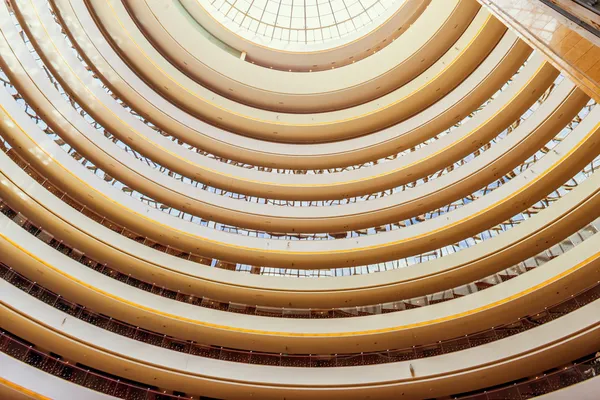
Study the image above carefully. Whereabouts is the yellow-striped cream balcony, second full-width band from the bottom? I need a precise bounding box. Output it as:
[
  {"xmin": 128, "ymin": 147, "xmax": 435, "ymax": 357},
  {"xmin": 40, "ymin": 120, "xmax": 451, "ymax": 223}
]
[{"xmin": 2, "ymin": 198, "xmax": 600, "ymax": 354}]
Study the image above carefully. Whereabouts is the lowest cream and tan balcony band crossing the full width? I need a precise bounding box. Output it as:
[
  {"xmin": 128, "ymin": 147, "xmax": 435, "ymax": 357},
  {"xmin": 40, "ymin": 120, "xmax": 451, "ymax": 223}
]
[{"xmin": 2, "ymin": 268, "xmax": 597, "ymax": 398}]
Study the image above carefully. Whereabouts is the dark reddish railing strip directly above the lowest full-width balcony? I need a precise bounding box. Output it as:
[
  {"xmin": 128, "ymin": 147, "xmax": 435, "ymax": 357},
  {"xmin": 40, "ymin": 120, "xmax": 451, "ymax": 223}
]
[{"xmin": 0, "ymin": 263, "xmax": 600, "ymax": 368}]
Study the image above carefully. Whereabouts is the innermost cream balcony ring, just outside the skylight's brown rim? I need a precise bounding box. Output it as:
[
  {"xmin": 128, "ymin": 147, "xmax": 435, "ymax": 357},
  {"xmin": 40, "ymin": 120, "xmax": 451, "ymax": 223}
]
[{"xmin": 124, "ymin": 0, "xmax": 454, "ymax": 109}]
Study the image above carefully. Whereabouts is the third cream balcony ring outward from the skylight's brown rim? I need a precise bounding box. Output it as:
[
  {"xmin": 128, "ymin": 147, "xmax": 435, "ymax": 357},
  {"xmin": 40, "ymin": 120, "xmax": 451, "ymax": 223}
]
[{"xmin": 52, "ymin": 1, "xmax": 536, "ymax": 170}]
